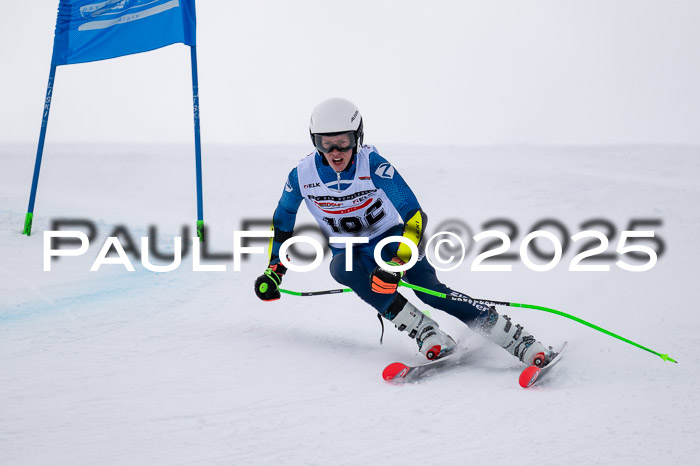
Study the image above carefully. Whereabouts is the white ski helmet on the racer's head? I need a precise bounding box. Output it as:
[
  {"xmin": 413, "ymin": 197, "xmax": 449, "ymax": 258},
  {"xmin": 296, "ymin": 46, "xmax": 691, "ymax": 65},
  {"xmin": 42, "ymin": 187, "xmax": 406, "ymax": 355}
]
[{"xmin": 309, "ymin": 97, "xmax": 364, "ymax": 153}]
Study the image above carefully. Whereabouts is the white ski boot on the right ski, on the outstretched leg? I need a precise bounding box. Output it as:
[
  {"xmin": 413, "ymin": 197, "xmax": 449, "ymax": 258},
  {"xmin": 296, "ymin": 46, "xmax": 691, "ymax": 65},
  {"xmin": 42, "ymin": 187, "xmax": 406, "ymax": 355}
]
[{"xmin": 478, "ymin": 306, "xmax": 557, "ymax": 367}]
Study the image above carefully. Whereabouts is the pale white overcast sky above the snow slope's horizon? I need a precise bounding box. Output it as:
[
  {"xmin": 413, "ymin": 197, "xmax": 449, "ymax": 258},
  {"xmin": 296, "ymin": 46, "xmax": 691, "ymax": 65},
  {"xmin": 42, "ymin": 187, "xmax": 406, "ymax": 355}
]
[{"xmin": 0, "ymin": 0, "xmax": 700, "ymax": 145}]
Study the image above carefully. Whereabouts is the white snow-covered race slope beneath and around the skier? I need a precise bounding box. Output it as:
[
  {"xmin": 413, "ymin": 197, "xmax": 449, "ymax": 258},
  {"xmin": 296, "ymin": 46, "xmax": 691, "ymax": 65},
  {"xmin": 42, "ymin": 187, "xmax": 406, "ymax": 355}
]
[{"xmin": 0, "ymin": 144, "xmax": 700, "ymax": 465}]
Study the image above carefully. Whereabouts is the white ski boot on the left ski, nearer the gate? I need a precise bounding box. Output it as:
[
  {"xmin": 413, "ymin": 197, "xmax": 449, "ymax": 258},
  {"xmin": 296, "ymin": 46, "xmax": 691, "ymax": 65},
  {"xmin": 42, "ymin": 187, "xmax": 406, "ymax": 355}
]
[{"xmin": 385, "ymin": 294, "xmax": 457, "ymax": 361}]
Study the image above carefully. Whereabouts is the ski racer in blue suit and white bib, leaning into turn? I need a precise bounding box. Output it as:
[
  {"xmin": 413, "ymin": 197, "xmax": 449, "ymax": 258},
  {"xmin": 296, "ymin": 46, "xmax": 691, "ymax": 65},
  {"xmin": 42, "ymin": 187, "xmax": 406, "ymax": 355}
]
[{"xmin": 255, "ymin": 98, "xmax": 555, "ymax": 367}]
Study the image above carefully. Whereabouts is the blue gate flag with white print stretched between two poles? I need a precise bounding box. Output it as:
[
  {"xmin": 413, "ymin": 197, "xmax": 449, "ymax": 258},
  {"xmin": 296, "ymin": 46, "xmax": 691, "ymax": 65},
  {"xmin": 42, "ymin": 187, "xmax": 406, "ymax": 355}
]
[{"xmin": 52, "ymin": 0, "xmax": 196, "ymax": 65}]
